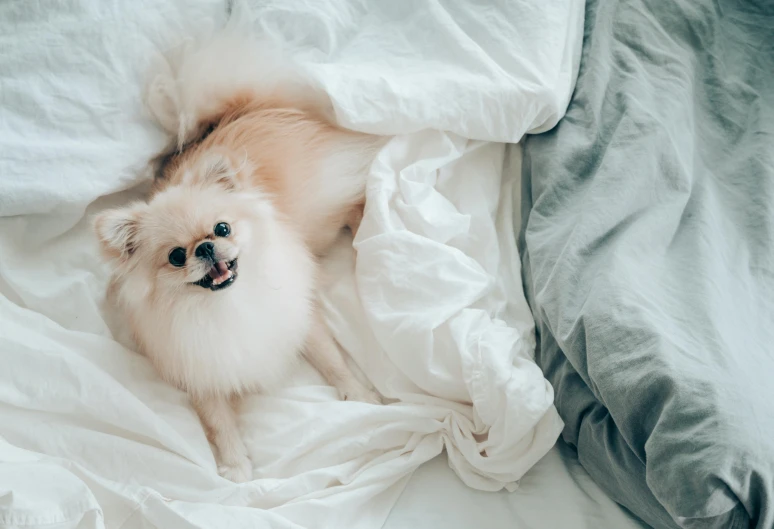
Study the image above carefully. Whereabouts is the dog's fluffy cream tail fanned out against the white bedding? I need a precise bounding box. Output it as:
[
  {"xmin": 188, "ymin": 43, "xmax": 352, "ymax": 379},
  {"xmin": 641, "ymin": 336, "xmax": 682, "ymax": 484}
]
[{"xmin": 146, "ymin": 14, "xmax": 332, "ymax": 149}]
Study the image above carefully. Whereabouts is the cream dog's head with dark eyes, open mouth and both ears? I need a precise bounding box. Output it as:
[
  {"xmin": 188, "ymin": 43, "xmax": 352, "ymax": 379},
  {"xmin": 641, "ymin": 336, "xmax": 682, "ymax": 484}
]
[{"xmin": 95, "ymin": 155, "xmax": 269, "ymax": 295}]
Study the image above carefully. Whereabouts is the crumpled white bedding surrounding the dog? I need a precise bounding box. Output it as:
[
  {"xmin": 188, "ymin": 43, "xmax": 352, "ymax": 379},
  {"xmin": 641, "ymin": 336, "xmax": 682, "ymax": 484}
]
[{"xmin": 0, "ymin": 0, "xmax": 583, "ymax": 529}]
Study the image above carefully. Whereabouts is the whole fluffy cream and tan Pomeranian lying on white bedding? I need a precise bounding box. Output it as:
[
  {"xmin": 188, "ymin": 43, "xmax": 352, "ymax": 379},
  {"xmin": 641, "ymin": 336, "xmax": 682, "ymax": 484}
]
[{"xmin": 94, "ymin": 29, "xmax": 383, "ymax": 482}]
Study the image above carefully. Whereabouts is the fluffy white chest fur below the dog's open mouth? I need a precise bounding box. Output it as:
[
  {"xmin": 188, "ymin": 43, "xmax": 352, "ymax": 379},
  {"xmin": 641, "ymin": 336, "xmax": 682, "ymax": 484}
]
[{"xmin": 124, "ymin": 244, "xmax": 313, "ymax": 395}]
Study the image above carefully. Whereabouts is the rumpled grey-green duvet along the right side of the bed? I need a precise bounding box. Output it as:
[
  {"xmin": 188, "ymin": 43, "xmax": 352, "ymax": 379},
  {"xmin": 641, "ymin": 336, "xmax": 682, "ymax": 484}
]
[{"xmin": 523, "ymin": 0, "xmax": 774, "ymax": 529}]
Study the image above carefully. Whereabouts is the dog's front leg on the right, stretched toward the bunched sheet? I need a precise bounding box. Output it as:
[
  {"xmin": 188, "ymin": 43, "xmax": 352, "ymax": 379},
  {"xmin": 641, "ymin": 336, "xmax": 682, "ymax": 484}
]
[{"xmin": 304, "ymin": 314, "xmax": 382, "ymax": 404}]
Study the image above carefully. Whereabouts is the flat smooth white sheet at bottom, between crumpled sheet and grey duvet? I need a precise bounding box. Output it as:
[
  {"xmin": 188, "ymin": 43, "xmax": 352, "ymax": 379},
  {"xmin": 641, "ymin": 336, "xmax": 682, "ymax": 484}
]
[{"xmin": 384, "ymin": 441, "xmax": 648, "ymax": 529}]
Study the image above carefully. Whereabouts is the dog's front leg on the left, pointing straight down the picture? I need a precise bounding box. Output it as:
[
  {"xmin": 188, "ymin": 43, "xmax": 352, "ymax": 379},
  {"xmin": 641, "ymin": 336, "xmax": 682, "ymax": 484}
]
[{"xmin": 193, "ymin": 397, "xmax": 253, "ymax": 483}]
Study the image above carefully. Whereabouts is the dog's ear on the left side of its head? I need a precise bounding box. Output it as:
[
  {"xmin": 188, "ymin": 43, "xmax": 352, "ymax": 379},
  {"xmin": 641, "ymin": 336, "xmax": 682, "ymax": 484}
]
[{"xmin": 94, "ymin": 202, "xmax": 147, "ymax": 260}]
